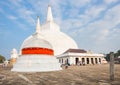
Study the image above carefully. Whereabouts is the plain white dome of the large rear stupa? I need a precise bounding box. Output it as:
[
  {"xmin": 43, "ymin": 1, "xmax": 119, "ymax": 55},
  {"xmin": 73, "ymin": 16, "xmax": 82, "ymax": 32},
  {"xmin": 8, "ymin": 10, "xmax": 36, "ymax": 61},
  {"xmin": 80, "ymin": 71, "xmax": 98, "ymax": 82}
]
[{"xmin": 41, "ymin": 30, "xmax": 78, "ymax": 55}]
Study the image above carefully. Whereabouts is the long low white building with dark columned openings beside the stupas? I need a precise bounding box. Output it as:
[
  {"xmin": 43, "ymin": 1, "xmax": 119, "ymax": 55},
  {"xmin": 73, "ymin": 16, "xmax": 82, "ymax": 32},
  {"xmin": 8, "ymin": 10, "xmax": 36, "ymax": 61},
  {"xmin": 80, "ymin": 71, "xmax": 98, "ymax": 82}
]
[{"xmin": 57, "ymin": 49, "xmax": 107, "ymax": 65}]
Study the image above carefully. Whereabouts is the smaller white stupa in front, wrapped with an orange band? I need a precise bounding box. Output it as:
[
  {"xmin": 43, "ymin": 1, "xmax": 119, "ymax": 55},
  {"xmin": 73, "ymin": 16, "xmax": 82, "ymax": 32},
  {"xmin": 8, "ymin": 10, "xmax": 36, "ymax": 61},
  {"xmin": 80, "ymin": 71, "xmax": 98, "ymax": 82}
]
[{"xmin": 12, "ymin": 17, "xmax": 61, "ymax": 72}]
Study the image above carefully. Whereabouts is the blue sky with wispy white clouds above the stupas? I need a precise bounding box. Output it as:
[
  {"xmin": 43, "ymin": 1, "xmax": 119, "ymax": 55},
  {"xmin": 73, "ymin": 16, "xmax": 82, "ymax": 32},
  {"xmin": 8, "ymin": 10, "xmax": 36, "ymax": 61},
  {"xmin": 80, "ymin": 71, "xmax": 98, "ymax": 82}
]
[{"xmin": 0, "ymin": 0, "xmax": 120, "ymax": 59}]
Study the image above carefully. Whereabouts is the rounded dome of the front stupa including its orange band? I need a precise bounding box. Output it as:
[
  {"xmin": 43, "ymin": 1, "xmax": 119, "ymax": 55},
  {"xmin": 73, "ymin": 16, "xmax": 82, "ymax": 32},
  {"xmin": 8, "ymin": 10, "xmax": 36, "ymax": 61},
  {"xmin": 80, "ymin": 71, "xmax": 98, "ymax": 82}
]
[{"xmin": 21, "ymin": 33, "xmax": 54, "ymax": 55}]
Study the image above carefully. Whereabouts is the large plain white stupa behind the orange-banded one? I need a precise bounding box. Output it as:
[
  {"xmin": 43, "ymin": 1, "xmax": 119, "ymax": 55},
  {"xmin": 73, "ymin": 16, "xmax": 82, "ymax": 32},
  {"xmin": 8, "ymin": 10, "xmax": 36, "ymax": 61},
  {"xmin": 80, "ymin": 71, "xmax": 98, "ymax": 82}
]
[{"xmin": 21, "ymin": 5, "xmax": 78, "ymax": 55}]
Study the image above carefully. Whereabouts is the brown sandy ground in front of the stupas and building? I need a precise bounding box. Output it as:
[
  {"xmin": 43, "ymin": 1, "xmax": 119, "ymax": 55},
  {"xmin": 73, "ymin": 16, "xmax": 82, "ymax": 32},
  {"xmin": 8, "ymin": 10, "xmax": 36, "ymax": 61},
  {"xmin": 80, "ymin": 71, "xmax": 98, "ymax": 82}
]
[{"xmin": 0, "ymin": 64, "xmax": 120, "ymax": 85}]
